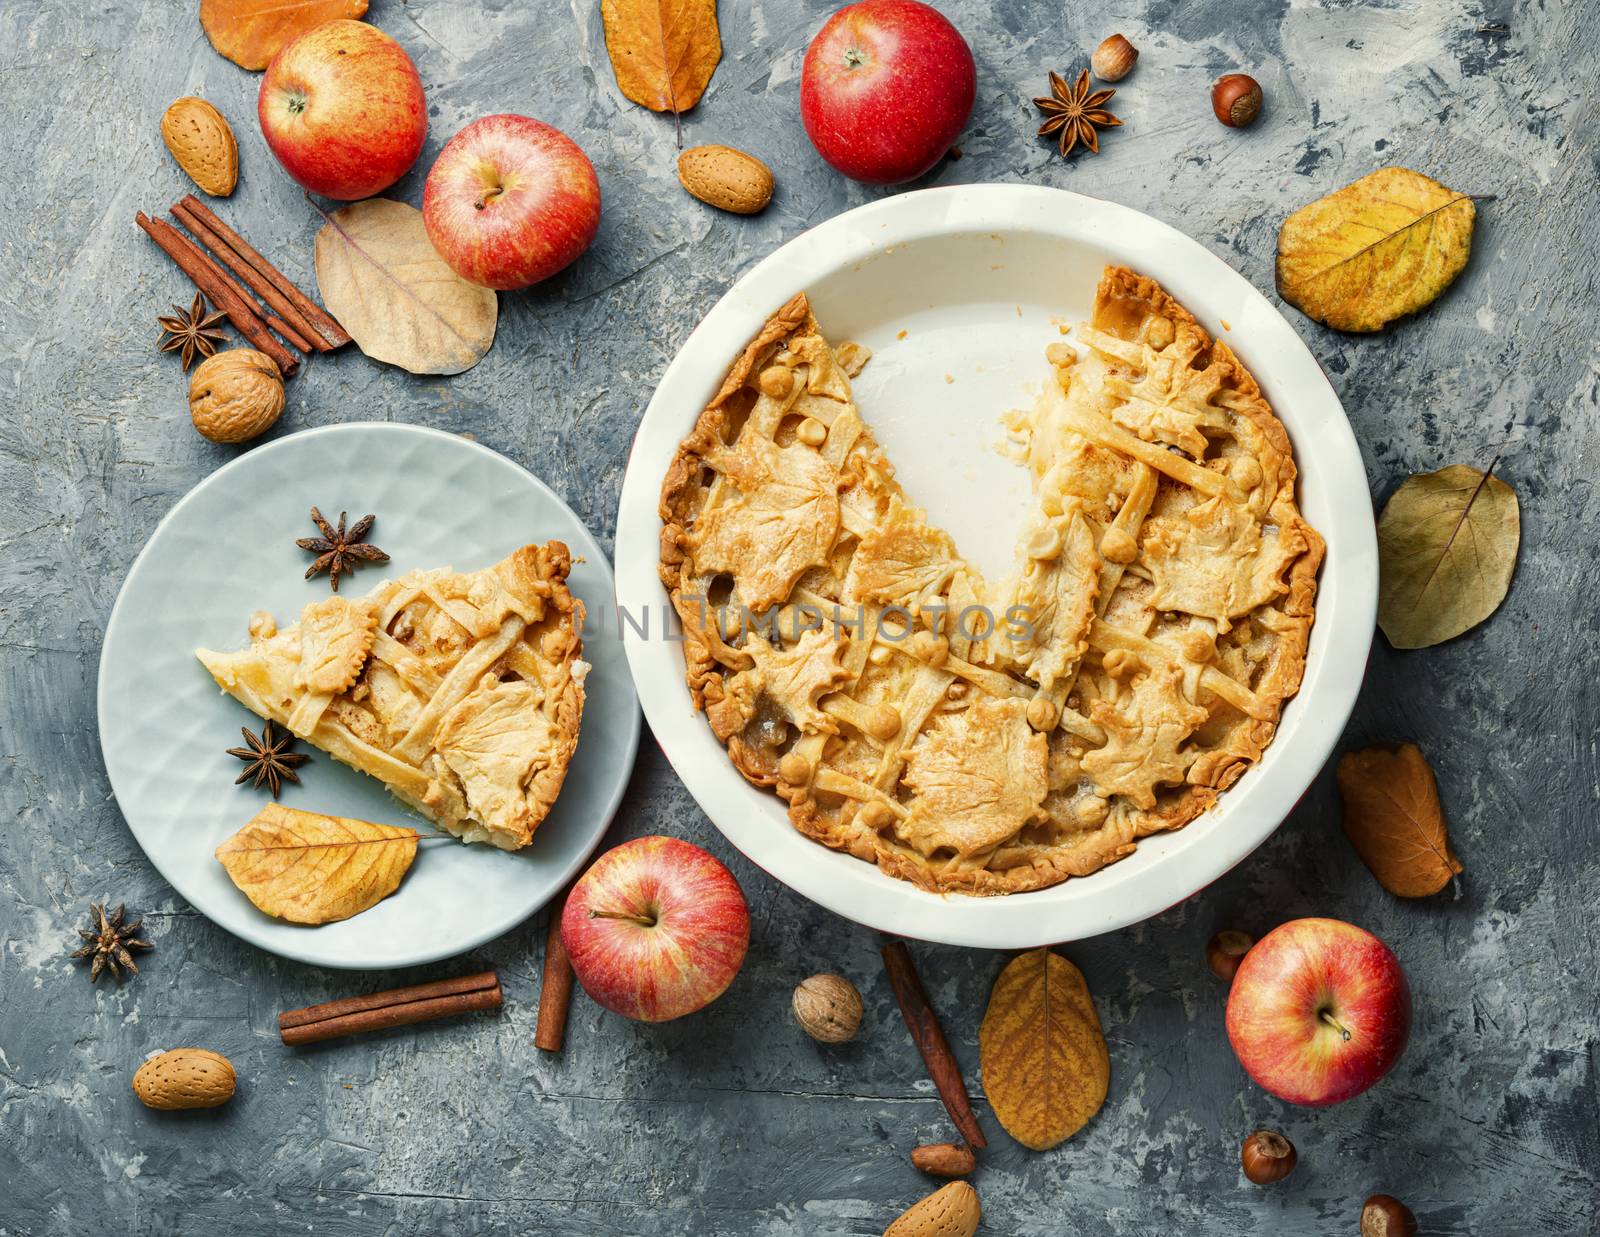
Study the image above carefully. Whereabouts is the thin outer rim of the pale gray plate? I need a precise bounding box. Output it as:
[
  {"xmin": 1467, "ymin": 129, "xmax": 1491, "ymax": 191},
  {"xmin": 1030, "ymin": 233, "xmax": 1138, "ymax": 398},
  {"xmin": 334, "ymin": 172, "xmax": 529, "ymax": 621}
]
[{"xmin": 94, "ymin": 421, "xmax": 642, "ymax": 971}]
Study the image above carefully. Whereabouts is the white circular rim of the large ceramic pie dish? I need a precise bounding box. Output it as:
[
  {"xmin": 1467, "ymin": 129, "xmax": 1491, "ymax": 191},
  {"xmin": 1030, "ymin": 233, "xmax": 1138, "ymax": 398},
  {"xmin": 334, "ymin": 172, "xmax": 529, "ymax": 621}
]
[{"xmin": 614, "ymin": 184, "xmax": 1378, "ymax": 949}]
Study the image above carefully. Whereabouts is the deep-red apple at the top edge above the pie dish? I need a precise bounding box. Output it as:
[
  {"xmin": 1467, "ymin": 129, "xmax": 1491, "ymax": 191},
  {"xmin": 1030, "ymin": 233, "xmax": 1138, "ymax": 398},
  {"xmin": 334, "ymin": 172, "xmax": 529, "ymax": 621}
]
[{"xmin": 800, "ymin": 0, "xmax": 978, "ymax": 184}]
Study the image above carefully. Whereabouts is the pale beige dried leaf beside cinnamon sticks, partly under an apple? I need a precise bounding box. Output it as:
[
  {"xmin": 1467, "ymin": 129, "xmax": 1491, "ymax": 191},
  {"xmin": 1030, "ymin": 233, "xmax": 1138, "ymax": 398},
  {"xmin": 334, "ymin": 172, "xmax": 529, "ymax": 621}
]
[{"xmin": 308, "ymin": 197, "xmax": 499, "ymax": 374}]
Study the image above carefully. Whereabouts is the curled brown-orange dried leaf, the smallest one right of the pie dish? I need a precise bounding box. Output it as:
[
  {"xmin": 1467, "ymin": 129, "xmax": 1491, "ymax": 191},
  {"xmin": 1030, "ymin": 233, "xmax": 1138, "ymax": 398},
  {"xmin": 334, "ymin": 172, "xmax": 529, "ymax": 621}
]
[{"xmin": 1339, "ymin": 743, "xmax": 1461, "ymax": 898}]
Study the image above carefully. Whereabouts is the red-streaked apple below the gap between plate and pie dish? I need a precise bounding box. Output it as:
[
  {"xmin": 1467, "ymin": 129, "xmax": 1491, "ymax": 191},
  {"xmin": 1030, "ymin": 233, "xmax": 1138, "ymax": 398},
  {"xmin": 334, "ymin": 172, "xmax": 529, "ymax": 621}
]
[{"xmin": 562, "ymin": 837, "xmax": 750, "ymax": 1023}]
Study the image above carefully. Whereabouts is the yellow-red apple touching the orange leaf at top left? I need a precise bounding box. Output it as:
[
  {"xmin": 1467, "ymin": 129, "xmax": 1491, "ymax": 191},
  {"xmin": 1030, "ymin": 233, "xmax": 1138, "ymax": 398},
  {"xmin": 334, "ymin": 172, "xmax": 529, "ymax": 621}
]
[{"xmin": 256, "ymin": 21, "xmax": 427, "ymax": 202}]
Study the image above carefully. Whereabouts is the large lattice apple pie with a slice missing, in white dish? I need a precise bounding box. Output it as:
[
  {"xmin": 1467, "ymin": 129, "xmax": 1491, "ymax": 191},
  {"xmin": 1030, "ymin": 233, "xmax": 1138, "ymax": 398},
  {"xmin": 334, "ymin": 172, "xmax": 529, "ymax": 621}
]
[{"xmin": 661, "ymin": 267, "xmax": 1323, "ymax": 895}]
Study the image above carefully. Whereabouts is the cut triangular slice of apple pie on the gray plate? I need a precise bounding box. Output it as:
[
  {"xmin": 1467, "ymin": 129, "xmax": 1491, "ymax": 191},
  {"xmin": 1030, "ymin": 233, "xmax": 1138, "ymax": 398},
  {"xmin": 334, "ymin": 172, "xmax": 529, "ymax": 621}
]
[{"xmin": 195, "ymin": 541, "xmax": 589, "ymax": 850}]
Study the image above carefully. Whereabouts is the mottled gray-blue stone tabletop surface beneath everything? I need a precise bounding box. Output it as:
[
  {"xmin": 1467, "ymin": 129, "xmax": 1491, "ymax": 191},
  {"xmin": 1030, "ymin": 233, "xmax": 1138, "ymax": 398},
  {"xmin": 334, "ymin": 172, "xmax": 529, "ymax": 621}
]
[{"xmin": 0, "ymin": 0, "xmax": 1600, "ymax": 1237}]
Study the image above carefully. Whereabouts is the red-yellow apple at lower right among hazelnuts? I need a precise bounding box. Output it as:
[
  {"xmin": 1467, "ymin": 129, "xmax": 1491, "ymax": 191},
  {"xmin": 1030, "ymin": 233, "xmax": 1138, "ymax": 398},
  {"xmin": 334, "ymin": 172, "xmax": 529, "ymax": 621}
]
[{"xmin": 1227, "ymin": 919, "xmax": 1411, "ymax": 1107}]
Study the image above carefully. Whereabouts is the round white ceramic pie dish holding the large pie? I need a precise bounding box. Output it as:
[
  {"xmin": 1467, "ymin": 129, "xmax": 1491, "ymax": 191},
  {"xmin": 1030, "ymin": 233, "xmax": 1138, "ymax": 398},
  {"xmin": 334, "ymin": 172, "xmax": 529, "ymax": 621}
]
[{"xmin": 616, "ymin": 186, "xmax": 1378, "ymax": 949}]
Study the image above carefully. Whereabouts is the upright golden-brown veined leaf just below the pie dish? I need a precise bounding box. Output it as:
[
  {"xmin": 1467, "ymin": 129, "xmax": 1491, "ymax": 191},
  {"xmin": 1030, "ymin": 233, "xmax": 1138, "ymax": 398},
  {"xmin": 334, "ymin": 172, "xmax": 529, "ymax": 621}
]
[{"xmin": 978, "ymin": 949, "xmax": 1110, "ymax": 1151}]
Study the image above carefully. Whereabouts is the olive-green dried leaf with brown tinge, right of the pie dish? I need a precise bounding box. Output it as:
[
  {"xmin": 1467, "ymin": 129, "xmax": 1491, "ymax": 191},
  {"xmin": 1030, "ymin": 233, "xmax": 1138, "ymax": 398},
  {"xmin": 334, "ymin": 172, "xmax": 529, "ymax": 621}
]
[{"xmin": 1378, "ymin": 464, "xmax": 1522, "ymax": 648}]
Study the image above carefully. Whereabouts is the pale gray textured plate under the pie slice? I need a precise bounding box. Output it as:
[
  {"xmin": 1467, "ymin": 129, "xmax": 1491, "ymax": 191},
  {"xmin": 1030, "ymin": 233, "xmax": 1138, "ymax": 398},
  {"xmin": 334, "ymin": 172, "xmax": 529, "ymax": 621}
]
[{"xmin": 99, "ymin": 424, "xmax": 640, "ymax": 970}]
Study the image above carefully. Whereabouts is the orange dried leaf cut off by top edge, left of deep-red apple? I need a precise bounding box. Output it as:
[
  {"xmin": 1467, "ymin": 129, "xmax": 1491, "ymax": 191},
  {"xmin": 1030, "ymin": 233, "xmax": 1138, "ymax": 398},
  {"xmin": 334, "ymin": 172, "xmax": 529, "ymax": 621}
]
[{"xmin": 600, "ymin": 0, "xmax": 722, "ymax": 140}]
